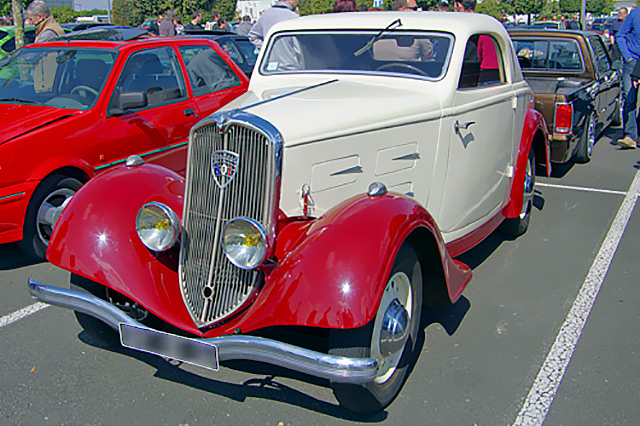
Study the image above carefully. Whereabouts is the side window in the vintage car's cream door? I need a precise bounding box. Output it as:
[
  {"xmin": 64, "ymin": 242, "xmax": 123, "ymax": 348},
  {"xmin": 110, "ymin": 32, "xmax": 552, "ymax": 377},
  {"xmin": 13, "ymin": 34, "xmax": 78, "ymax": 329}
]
[{"xmin": 458, "ymin": 34, "xmax": 506, "ymax": 89}]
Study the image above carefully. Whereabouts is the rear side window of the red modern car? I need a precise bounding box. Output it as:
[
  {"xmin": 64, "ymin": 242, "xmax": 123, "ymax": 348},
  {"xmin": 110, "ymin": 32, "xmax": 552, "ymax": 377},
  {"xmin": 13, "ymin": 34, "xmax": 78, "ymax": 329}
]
[{"xmin": 180, "ymin": 46, "xmax": 240, "ymax": 96}]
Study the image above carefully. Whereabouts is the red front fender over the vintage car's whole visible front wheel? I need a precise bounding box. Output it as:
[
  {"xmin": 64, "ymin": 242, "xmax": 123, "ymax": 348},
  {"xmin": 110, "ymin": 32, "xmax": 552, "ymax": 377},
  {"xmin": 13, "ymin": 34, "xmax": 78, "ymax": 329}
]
[{"xmin": 228, "ymin": 194, "xmax": 471, "ymax": 332}]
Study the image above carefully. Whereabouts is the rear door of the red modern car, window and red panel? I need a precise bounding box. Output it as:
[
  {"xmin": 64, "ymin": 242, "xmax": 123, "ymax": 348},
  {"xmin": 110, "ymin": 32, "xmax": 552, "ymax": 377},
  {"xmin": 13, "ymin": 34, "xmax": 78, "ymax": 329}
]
[{"xmin": 179, "ymin": 44, "xmax": 248, "ymax": 118}]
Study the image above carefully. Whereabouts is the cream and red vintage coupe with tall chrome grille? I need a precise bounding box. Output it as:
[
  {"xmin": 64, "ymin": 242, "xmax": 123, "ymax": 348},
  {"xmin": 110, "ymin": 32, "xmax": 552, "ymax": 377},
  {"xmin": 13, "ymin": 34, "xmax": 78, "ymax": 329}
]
[{"xmin": 29, "ymin": 12, "xmax": 548, "ymax": 413}]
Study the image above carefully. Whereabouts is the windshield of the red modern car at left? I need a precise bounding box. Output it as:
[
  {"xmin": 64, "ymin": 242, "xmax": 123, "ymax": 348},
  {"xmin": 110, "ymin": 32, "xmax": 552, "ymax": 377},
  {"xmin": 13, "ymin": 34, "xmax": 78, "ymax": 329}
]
[{"xmin": 0, "ymin": 47, "xmax": 117, "ymax": 109}]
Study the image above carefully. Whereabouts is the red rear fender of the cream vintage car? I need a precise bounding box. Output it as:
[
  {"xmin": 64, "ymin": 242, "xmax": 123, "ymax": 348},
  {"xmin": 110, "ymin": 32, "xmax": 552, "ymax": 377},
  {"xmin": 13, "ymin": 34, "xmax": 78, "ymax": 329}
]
[{"xmin": 502, "ymin": 108, "xmax": 551, "ymax": 218}]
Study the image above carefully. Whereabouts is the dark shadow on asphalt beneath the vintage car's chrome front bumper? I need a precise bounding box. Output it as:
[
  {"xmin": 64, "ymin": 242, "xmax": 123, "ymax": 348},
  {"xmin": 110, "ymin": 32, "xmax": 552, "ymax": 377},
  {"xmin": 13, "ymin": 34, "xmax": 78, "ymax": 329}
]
[{"xmin": 78, "ymin": 331, "xmax": 388, "ymax": 423}]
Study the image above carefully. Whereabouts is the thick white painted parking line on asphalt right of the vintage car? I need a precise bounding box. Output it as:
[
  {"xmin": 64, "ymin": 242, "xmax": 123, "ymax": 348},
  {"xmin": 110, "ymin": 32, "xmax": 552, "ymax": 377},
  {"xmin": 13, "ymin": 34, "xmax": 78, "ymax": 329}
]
[{"xmin": 513, "ymin": 171, "xmax": 640, "ymax": 426}]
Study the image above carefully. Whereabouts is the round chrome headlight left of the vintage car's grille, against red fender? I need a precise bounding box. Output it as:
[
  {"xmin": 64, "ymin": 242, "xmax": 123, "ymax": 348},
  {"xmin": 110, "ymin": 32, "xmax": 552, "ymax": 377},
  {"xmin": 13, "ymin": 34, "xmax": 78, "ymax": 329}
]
[{"xmin": 136, "ymin": 203, "xmax": 180, "ymax": 251}]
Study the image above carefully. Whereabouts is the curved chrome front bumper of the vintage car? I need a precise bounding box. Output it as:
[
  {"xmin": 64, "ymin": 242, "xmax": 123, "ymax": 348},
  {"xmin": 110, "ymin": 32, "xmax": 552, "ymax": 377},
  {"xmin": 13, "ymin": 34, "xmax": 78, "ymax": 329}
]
[{"xmin": 29, "ymin": 278, "xmax": 378, "ymax": 383}]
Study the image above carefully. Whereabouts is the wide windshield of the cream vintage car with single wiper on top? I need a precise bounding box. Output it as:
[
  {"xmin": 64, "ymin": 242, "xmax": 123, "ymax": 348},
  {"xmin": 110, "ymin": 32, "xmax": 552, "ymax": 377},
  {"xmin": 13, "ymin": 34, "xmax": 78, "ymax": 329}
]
[{"xmin": 260, "ymin": 30, "xmax": 453, "ymax": 80}]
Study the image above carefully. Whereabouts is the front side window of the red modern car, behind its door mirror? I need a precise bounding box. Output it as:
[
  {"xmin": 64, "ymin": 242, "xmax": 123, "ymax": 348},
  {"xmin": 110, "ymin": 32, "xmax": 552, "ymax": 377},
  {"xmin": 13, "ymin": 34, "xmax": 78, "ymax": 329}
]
[{"xmin": 109, "ymin": 47, "xmax": 187, "ymax": 110}]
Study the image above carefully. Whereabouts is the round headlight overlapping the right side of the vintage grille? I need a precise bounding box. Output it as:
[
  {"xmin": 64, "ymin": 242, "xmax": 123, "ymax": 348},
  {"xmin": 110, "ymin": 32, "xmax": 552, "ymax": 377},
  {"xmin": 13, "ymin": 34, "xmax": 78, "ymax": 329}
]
[{"xmin": 222, "ymin": 217, "xmax": 267, "ymax": 269}]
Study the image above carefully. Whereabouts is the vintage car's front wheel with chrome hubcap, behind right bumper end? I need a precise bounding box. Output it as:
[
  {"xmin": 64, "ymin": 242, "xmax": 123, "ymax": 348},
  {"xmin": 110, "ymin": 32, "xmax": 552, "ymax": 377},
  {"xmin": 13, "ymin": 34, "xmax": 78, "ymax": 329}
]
[{"xmin": 329, "ymin": 243, "xmax": 422, "ymax": 414}]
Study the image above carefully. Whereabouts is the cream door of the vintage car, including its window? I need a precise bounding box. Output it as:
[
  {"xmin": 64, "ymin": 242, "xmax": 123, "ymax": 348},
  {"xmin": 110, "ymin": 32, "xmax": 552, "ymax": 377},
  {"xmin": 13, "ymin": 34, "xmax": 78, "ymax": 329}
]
[{"xmin": 439, "ymin": 35, "xmax": 517, "ymax": 233}]
